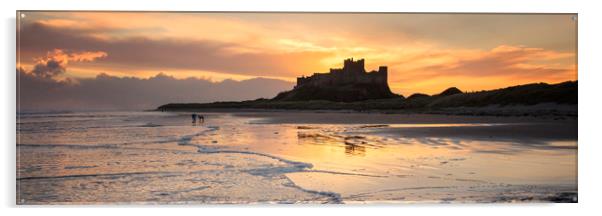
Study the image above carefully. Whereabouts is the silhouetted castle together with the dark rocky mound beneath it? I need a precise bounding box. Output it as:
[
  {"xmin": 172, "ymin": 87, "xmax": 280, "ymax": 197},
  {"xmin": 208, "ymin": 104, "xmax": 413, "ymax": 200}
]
[{"xmin": 274, "ymin": 58, "xmax": 399, "ymax": 102}]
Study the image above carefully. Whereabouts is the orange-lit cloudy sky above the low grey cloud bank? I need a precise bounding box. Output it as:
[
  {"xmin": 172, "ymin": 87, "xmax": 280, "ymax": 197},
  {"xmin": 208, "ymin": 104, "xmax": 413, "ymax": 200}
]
[{"xmin": 18, "ymin": 12, "xmax": 576, "ymax": 95}]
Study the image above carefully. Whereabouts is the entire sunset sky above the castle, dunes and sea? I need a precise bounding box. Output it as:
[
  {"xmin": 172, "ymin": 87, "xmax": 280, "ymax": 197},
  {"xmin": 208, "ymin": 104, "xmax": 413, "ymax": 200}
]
[{"xmin": 17, "ymin": 12, "xmax": 577, "ymax": 109}]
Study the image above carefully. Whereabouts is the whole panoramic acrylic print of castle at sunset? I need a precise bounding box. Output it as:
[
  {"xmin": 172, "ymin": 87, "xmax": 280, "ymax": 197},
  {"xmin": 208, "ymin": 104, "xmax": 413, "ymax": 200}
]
[{"xmin": 16, "ymin": 11, "xmax": 578, "ymax": 204}]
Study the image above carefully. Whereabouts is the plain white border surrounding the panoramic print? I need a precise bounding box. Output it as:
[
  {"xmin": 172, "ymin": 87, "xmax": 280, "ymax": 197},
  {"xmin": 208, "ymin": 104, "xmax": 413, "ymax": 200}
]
[{"xmin": 0, "ymin": 0, "xmax": 602, "ymax": 215}]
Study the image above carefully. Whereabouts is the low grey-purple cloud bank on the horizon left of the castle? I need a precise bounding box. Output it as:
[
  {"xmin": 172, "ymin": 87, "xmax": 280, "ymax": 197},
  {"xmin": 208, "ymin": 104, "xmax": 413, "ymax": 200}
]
[{"xmin": 17, "ymin": 69, "xmax": 293, "ymax": 111}]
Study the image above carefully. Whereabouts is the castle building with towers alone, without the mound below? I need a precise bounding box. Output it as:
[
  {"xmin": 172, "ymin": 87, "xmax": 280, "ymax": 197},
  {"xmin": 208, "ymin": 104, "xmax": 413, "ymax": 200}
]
[{"xmin": 295, "ymin": 58, "xmax": 388, "ymax": 88}]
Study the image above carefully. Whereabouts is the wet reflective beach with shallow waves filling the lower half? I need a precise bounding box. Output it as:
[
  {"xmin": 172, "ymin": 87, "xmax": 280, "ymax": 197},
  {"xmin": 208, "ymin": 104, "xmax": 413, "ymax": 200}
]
[{"xmin": 17, "ymin": 110, "xmax": 577, "ymax": 204}]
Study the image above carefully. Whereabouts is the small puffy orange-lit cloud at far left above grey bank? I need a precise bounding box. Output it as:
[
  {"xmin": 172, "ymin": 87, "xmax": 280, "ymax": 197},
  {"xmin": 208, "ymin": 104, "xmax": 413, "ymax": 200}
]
[{"xmin": 31, "ymin": 49, "xmax": 107, "ymax": 78}]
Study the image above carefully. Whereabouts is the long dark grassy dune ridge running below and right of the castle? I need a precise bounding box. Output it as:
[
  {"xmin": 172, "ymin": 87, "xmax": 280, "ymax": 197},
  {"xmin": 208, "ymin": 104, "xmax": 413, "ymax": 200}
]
[{"xmin": 157, "ymin": 81, "xmax": 577, "ymax": 116}]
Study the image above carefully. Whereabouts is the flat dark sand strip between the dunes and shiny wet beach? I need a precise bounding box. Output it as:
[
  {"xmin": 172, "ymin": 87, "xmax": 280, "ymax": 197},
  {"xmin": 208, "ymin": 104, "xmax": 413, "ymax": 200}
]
[{"xmin": 235, "ymin": 112, "xmax": 577, "ymax": 141}]
